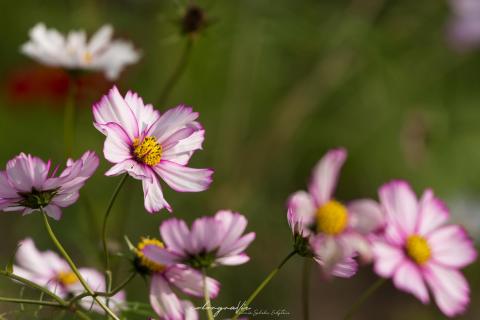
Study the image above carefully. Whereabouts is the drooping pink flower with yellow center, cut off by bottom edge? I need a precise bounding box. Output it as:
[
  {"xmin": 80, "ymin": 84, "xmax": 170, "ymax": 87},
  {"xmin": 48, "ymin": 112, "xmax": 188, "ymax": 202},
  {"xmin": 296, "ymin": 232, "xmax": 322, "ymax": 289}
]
[{"xmin": 135, "ymin": 238, "xmax": 220, "ymax": 320}]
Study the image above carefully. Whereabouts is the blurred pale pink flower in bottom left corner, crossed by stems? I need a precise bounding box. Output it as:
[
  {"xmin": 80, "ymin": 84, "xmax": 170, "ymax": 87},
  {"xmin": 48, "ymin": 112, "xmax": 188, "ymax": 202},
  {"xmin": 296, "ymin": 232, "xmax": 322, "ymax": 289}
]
[{"xmin": 13, "ymin": 238, "xmax": 125, "ymax": 313}]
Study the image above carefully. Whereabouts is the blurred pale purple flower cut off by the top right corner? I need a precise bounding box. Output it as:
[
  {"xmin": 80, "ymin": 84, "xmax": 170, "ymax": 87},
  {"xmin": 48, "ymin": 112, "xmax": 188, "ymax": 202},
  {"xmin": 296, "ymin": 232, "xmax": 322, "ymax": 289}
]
[{"xmin": 447, "ymin": 0, "xmax": 480, "ymax": 51}]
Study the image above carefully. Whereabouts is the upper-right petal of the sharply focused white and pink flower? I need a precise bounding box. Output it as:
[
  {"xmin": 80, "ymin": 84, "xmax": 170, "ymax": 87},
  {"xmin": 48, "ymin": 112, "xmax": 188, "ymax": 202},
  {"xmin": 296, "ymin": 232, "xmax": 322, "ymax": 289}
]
[{"xmin": 149, "ymin": 105, "xmax": 199, "ymax": 144}]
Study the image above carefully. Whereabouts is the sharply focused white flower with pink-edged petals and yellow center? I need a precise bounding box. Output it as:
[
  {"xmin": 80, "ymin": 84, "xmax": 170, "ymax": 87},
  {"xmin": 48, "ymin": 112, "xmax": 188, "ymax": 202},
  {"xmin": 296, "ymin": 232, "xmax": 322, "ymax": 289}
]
[{"xmin": 93, "ymin": 87, "xmax": 213, "ymax": 213}]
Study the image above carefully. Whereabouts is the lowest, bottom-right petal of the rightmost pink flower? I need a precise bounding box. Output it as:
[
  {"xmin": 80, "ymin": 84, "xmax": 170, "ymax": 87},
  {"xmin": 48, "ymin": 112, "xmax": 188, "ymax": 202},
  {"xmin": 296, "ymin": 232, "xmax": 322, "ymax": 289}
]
[{"xmin": 425, "ymin": 263, "xmax": 470, "ymax": 317}]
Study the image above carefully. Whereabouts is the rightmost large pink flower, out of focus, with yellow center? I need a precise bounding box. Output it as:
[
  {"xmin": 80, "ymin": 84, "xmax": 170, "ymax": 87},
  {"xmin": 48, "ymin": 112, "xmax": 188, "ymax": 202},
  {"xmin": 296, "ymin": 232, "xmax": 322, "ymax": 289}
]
[{"xmin": 373, "ymin": 181, "xmax": 477, "ymax": 317}]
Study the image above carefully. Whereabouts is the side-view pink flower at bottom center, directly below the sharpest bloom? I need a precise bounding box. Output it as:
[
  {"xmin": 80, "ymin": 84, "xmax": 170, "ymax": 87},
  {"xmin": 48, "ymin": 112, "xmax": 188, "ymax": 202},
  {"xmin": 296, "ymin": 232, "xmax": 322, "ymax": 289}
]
[{"xmin": 160, "ymin": 210, "xmax": 255, "ymax": 269}]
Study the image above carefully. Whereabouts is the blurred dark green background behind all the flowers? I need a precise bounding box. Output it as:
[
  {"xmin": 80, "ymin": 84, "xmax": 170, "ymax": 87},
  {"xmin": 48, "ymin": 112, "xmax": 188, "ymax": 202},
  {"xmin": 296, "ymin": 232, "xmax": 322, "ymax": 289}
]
[{"xmin": 0, "ymin": 0, "xmax": 480, "ymax": 320}]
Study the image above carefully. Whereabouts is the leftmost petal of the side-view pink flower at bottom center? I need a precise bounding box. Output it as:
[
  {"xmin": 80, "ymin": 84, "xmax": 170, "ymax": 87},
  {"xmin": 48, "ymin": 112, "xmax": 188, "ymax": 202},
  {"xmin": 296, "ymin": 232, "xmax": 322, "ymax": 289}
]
[{"xmin": 160, "ymin": 218, "xmax": 193, "ymax": 255}]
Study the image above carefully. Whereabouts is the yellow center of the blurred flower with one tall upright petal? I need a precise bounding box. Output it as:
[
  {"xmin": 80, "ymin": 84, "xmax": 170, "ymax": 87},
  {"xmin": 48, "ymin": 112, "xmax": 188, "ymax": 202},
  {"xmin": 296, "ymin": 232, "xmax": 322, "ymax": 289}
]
[{"xmin": 317, "ymin": 200, "xmax": 348, "ymax": 235}]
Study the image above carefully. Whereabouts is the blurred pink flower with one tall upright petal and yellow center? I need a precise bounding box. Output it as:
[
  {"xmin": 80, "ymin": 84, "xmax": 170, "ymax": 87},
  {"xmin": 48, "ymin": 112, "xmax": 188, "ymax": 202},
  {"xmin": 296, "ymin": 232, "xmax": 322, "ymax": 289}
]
[{"xmin": 288, "ymin": 149, "xmax": 383, "ymax": 277}]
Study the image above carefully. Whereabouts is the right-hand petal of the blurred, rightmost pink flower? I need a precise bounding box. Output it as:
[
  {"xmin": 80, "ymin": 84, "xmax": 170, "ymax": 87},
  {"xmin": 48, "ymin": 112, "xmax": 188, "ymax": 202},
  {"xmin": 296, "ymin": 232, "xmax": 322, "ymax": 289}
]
[{"xmin": 428, "ymin": 225, "xmax": 477, "ymax": 268}]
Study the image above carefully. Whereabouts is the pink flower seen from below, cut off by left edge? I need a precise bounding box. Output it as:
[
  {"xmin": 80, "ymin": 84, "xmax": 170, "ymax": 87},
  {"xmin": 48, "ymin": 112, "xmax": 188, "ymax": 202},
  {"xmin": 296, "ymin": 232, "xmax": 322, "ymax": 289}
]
[{"xmin": 0, "ymin": 151, "xmax": 99, "ymax": 220}]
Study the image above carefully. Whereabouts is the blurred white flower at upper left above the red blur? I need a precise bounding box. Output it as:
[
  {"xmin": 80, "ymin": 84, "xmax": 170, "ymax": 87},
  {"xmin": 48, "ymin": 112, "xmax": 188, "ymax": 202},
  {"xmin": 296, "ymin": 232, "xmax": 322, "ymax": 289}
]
[{"xmin": 21, "ymin": 23, "xmax": 140, "ymax": 80}]
